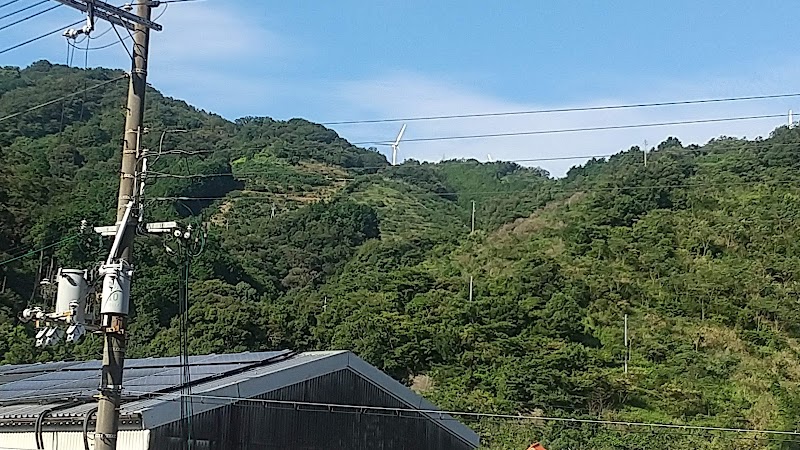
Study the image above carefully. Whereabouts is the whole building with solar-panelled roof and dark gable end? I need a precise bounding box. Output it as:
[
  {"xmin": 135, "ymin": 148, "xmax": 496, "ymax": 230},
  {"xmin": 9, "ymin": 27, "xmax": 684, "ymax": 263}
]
[{"xmin": 0, "ymin": 351, "xmax": 479, "ymax": 450}]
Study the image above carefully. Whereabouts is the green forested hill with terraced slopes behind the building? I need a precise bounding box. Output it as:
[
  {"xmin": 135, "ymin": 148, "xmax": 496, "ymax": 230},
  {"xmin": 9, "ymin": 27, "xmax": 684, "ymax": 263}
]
[{"xmin": 0, "ymin": 62, "xmax": 800, "ymax": 450}]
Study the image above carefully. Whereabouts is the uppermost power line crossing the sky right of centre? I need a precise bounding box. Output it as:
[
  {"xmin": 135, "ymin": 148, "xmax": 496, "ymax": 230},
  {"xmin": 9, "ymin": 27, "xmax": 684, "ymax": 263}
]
[{"xmin": 321, "ymin": 92, "xmax": 800, "ymax": 125}]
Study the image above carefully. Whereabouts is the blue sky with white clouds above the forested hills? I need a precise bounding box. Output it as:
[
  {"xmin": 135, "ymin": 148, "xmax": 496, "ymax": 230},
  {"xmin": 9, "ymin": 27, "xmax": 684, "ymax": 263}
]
[{"xmin": 0, "ymin": 0, "xmax": 800, "ymax": 175}]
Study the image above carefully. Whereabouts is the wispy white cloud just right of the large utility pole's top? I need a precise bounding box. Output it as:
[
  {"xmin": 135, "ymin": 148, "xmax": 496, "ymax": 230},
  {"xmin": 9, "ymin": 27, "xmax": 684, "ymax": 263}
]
[{"xmin": 138, "ymin": 1, "xmax": 306, "ymax": 118}]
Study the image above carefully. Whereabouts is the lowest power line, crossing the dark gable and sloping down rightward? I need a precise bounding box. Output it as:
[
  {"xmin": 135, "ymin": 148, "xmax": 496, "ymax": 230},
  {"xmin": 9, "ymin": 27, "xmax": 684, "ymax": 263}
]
[{"xmin": 122, "ymin": 391, "xmax": 800, "ymax": 436}]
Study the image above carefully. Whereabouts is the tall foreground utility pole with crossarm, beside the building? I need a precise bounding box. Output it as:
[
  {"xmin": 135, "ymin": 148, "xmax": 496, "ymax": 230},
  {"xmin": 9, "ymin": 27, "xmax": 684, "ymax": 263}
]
[{"xmin": 51, "ymin": 0, "xmax": 161, "ymax": 450}]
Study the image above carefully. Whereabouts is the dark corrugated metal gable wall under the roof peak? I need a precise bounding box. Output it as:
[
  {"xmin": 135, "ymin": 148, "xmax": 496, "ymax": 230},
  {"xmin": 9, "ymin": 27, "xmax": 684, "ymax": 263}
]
[{"xmin": 150, "ymin": 369, "xmax": 472, "ymax": 450}]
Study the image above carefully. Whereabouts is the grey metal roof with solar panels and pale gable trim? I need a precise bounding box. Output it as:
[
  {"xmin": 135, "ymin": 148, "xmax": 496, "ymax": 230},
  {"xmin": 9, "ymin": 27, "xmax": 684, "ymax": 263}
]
[{"xmin": 0, "ymin": 351, "xmax": 479, "ymax": 446}]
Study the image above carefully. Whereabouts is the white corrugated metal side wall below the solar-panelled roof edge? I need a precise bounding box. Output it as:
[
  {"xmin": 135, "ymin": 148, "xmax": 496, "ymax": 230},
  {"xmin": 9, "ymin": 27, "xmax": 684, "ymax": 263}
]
[{"xmin": 0, "ymin": 430, "xmax": 150, "ymax": 450}]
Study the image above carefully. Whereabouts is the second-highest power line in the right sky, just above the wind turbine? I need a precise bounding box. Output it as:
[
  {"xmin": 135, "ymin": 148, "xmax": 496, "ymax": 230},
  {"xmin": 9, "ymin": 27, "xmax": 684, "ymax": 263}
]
[{"xmin": 352, "ymin": 114, "xmax": 786, "ymax": 145}]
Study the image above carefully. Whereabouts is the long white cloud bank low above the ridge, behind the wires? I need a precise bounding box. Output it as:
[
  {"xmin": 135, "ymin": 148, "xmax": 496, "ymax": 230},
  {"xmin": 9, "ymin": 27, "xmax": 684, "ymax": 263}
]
[{"xmin": 324, "ymin": 73, "xmax": 797, "ymax": 176}]
